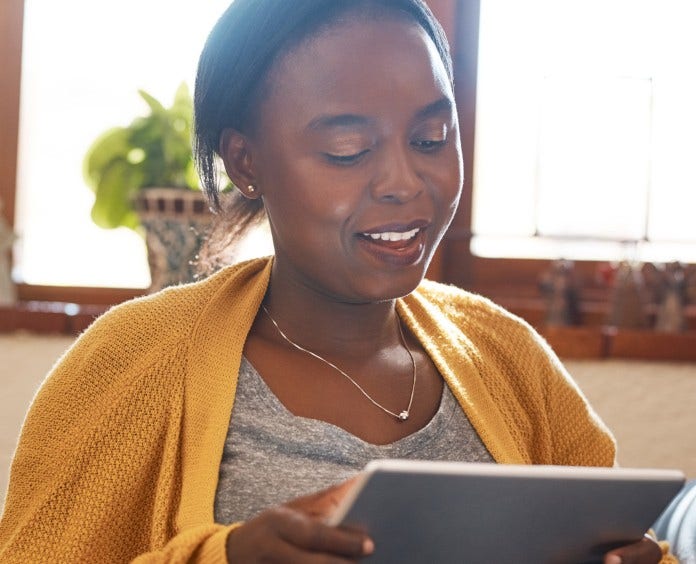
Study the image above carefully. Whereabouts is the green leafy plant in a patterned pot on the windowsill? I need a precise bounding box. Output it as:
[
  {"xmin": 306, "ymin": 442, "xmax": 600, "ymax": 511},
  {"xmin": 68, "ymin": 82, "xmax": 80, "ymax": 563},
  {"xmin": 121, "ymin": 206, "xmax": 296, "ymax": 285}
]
[{"xmin": 83, "ymin": 83, "xmax": 212, "ymax": 291}]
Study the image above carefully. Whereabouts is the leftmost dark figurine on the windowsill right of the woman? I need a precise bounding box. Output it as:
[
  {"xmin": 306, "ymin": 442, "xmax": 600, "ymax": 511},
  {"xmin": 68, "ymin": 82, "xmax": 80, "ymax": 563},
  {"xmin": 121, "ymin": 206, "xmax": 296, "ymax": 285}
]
[{"xmin": 539, "ymin": 259, "xmax": 580, "ymax": 326}]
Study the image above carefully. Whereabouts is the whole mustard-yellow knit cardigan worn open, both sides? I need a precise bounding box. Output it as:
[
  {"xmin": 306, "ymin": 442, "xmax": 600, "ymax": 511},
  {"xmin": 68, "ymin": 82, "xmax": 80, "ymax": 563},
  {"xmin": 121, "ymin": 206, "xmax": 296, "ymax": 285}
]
[{"xmin": 0, "ymin": 259, "xmax": 636, "ymax": 564}]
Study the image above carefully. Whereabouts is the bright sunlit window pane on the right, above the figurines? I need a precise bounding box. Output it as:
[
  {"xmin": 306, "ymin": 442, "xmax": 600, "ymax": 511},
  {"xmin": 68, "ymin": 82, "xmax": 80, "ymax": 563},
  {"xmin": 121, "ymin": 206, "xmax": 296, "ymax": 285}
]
[{"xmin": 473, "ymin": 0, "xmax": 696, "ymax": 261}]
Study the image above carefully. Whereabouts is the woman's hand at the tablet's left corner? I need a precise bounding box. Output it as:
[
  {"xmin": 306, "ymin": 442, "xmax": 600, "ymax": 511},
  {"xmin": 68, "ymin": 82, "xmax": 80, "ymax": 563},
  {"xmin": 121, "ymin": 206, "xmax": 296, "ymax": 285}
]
[{"xmin": 227, "ymin": 480, "xmax": 374, "ymax": 564}]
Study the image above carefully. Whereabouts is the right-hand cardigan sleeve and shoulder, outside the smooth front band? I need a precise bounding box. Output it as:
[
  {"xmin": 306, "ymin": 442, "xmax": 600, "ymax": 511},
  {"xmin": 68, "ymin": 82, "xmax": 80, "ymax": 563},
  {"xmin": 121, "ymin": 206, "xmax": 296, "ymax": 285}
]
[{"xmin": 448, "ymin": 290, "xmax": 616, "ymax": 466}]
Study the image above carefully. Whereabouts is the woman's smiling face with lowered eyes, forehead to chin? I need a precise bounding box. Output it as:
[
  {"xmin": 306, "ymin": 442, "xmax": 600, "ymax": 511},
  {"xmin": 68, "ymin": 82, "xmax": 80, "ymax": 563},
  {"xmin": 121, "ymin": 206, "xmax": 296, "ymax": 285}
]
[{"xmin": 249, "ymin": 14, "xmax": 462, "ymax": 303}]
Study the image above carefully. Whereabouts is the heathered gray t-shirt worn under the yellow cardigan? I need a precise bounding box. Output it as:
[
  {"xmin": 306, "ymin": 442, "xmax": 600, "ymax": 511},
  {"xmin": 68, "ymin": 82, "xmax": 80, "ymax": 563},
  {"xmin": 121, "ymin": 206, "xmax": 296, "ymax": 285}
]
[{"xmin": 215, "ymin": 358, "xmax": 493, "ymax": 524}]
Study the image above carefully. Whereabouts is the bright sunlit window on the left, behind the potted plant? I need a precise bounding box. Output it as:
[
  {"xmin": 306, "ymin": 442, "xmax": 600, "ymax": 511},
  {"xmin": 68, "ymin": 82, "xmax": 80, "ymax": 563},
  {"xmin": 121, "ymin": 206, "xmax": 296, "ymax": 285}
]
[{"xmin": 14, "ymin": 0, "xmax": 229, "ymax": 287}]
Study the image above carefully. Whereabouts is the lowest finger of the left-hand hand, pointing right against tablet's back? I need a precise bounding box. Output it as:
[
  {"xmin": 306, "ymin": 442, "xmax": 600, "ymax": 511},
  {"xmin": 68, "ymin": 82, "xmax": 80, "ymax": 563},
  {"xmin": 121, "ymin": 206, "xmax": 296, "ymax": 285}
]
[{"xmin": 278, "ymin": 508, "xmax": 374, "ymax": 558}]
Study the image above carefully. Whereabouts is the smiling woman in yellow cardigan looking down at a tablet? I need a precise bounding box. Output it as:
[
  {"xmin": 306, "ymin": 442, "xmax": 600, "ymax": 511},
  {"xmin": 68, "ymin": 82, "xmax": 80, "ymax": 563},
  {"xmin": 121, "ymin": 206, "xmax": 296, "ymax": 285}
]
[{"xmin": 0, "ymin": 0, "xmax": 676, "ymax": 562}]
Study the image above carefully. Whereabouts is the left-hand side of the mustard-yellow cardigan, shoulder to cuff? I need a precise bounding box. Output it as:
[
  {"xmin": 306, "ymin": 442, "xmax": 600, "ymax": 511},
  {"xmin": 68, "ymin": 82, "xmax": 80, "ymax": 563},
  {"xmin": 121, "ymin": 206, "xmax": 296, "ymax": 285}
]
[{"xmin": 0, "ymin": 261, "xmax": 270, "ymax": 564}]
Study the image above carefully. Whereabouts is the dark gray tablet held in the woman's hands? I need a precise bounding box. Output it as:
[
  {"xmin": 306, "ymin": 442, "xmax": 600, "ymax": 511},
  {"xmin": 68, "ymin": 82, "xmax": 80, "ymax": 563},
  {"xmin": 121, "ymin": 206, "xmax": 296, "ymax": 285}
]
[{"xmin": 331, "ymin": 460, "xmax": 684, "ymax": 564}]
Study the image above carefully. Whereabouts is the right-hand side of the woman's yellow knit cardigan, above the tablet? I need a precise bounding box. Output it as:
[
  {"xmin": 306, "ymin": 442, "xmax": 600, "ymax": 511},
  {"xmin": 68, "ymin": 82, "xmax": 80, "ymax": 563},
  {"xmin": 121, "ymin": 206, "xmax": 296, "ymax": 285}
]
[{"xmin": 398, "ymin": 281, "xmax": 615, "ymax": 466}]
